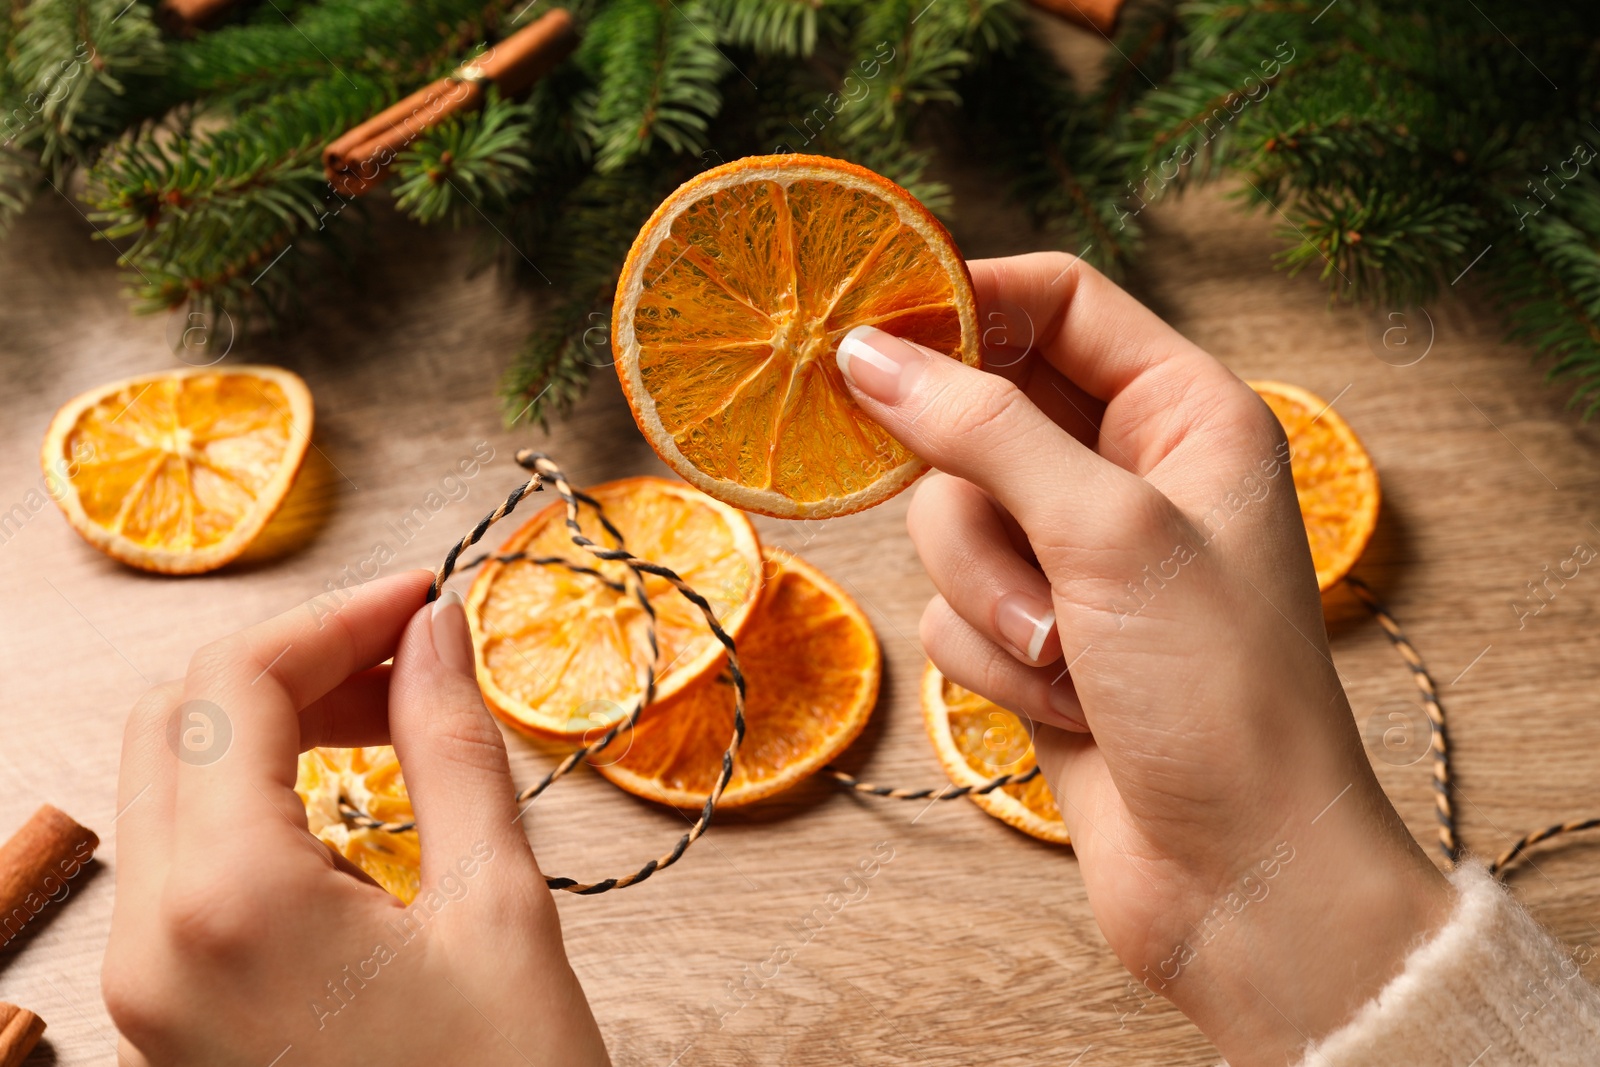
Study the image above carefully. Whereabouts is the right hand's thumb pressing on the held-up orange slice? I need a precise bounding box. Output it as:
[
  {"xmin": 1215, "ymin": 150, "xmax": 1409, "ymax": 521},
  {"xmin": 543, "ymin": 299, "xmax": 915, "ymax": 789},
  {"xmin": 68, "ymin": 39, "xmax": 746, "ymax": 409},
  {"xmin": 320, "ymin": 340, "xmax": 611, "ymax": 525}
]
[{"xmin": 835, "ymin": 326, "xmax": 1142, "ymax": 530}]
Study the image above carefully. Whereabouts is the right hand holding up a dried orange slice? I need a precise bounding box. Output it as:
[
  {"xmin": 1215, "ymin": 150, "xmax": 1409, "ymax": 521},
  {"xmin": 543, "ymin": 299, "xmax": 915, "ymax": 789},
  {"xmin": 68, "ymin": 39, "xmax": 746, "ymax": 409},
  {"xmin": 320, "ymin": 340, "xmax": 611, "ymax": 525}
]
[{"xmin": 838, "ymin": 253, "xmax": 1451, "ymax": 1067}]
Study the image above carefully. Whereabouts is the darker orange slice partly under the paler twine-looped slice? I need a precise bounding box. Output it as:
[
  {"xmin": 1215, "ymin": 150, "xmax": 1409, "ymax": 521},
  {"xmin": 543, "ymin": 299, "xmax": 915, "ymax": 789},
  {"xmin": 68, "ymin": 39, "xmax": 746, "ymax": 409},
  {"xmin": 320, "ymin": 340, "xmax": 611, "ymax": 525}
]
[{"xmin": 590, "ymin": 549, "xmax": 882, "ymax": 808}]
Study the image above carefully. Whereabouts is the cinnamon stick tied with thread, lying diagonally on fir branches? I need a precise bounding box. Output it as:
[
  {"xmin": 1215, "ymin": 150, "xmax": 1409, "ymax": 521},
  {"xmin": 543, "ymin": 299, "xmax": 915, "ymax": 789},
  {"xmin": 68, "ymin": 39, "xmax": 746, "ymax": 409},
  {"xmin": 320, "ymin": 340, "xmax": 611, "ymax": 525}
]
[{"xmin": 322, "ymin": 8, "xmax": 576, "ymax": 197}]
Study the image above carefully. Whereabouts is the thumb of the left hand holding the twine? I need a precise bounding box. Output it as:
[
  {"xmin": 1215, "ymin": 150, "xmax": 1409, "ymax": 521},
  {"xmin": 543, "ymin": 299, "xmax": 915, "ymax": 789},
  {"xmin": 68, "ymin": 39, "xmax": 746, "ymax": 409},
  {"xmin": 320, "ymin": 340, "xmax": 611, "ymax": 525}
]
[{"xmin": 389, "ymin": 592, "xmax": 538, "ymax": 888}]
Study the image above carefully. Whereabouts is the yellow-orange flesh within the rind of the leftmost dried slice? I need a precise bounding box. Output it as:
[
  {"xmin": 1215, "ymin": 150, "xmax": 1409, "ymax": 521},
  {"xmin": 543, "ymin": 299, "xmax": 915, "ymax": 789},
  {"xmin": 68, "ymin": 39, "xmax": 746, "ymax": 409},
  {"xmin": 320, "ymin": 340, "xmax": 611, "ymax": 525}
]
[{"xmin": 62, "ymin": 374, "xmax": 293, "ymax": 550}]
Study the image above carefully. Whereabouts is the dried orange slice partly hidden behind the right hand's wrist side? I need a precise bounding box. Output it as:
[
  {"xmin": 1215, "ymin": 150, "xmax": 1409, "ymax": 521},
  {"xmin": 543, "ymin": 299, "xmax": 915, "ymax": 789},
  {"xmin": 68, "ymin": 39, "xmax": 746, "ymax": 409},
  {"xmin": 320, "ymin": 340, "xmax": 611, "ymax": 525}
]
[{"xmin": 1250, "ymin": 382, "xmax": 1381, "ymax": 592}]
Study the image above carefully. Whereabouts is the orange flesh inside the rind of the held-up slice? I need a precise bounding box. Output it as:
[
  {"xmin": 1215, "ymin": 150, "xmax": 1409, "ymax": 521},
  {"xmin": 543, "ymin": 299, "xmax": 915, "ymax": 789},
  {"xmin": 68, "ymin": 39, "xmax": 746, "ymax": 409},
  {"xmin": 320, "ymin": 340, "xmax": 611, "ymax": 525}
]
[{"xmin": 634, "ymin": 179, "xmax": 962, "ymax": 501}]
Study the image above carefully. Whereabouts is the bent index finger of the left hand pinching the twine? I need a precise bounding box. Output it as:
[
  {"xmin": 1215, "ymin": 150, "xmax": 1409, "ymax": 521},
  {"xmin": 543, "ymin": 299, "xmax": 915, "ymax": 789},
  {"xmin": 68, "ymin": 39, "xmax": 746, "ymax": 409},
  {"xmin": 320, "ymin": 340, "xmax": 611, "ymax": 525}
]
[{"xmin": 178, "ymin": 571, "xmax": 434, "ymax": 840}]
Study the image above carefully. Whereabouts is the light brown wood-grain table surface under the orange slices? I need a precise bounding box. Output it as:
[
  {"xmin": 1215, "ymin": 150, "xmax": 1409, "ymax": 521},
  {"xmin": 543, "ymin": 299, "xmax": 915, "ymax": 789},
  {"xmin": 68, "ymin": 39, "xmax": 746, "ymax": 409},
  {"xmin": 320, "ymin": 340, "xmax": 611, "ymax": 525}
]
[{"xmin": 0, "ymin": 143, "xmax": 1600, "ymax": 1067}]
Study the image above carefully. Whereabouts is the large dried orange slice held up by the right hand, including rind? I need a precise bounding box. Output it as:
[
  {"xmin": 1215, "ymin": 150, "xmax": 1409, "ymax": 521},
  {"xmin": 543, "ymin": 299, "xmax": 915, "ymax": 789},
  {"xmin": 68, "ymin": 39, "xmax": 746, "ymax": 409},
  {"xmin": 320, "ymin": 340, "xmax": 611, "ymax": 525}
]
[{"xmin": 611, "ymin": 155, "xmax": 979, "ymax": 518}]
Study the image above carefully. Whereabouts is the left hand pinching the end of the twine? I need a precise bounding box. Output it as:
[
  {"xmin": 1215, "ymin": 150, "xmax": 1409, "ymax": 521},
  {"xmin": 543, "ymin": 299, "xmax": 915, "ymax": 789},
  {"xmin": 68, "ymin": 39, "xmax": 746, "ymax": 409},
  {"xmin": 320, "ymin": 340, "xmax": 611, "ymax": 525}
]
[{"xmin": 102, "ymin": 571, "xmax": 606, "ymax": 1067}]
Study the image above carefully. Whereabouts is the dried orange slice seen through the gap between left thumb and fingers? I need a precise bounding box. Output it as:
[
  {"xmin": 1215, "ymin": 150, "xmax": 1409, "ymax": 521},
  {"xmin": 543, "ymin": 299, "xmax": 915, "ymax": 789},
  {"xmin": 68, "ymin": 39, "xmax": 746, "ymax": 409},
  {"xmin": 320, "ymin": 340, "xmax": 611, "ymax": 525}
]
[{"xmin": 294, "ymin": 745, "xmax": 422, "ymax": 904}]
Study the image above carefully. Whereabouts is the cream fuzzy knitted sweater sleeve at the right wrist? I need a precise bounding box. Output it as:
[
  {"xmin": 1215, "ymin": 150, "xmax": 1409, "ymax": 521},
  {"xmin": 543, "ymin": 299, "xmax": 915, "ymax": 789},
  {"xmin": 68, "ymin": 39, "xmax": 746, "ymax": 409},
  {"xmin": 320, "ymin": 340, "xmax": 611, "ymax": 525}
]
[{"xmin": 1301, "ymin": 864, "xmax": 1600, "ymax": 1067}]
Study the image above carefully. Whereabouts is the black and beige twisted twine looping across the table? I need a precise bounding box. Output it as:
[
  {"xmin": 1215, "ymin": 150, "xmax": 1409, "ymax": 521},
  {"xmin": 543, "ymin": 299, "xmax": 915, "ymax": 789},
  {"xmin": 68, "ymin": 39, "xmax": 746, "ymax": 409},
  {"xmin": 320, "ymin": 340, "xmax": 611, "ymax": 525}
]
[{"xmin": 339, "ymin": 460, "xmax": 1600, "ymax": 896}]
